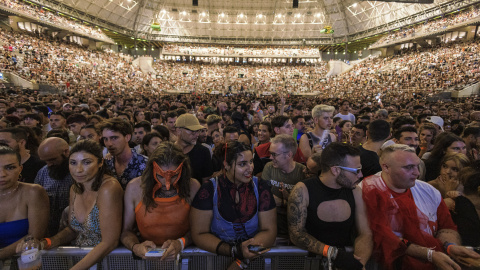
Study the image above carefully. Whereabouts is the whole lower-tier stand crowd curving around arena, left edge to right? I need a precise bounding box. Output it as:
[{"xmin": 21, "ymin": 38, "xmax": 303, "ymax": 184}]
[{"xmin": 0, "ymin": 22, "xmax": 479, "ymax": 98}]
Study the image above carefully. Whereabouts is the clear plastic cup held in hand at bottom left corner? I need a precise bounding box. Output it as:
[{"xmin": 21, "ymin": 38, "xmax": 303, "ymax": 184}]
[{"xmin": 17, "ymin": 235, "xmax": 42, "ymax": 270}]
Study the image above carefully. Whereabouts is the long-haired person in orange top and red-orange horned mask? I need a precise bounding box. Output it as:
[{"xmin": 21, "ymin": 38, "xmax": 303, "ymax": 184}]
[{"xmin": 120, "ymin": 141, "xmax": 200, "ymax": 260}]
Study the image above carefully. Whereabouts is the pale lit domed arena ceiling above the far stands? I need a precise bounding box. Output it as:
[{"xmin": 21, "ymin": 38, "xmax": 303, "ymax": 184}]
[{"xmin": 34, "ymin": 0, "xmax": 477, "ymax": 44}]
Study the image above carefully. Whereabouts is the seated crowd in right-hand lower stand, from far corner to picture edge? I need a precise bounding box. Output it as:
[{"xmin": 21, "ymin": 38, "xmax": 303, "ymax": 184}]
[{"xmin": 318, "ymin": 41, "xmax": 479, "ymax": 99}]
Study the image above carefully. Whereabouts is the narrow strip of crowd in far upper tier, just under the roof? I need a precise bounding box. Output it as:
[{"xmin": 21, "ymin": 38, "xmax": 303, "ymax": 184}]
[{"xmin": 163, "ymin": 44, "xmax": 320, "ymax": 57}]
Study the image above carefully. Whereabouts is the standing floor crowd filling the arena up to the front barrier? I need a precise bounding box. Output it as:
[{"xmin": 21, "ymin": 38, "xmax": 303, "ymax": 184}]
[{"xmin": 0, "ymin": 80, "xmax": 480, "ymax": 269}]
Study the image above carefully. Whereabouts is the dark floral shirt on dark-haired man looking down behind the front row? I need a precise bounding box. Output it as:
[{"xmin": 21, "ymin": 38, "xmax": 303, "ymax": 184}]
[{"xmin": 105, "ymin": 149, "xmax": 148, "ymax": 189}]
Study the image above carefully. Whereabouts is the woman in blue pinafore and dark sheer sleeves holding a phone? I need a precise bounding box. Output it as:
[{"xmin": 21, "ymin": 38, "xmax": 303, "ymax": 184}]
[{"xmin": 190, "ymin": 141, "xmax": 277, "ymax": 269}]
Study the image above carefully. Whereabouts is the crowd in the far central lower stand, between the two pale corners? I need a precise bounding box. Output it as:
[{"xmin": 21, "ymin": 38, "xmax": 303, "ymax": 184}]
[{"xmin": 153, "ymin": 61, "xmax": 328, "ymax": 93}]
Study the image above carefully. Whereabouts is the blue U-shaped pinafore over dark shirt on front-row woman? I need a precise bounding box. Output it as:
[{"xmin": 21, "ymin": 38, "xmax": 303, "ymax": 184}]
[{"xmin": 210, "ymin": 176, "xmax": 259, "ymax": 243}]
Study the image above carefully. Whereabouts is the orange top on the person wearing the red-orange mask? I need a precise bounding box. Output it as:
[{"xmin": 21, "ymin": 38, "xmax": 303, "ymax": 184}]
[{"xmin": 135, "ymin": 195, "xmax": 190, "ymax": 246}]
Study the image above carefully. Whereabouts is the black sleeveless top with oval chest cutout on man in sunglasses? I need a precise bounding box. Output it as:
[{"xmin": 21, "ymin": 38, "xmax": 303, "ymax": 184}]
[{"xmin": 303, "ymin": 177, "xmax": 355, "ymax": 247}]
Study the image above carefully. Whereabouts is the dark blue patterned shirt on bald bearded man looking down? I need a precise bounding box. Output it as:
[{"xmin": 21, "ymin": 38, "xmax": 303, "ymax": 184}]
[{"xmin": 34, "ymin": 165, "xmax": 73, "ymax": 237}]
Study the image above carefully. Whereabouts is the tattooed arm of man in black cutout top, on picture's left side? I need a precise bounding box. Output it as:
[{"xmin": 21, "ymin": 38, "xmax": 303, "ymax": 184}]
[{"xmin": 287, "ymin": 182, "xmax": 325, "ymax": 255}]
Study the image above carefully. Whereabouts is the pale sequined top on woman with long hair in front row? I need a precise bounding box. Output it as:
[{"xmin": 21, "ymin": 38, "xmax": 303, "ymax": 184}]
[{"xmin": 70, "ymin": 193, "xmax": 102, "ymax": 247}]
